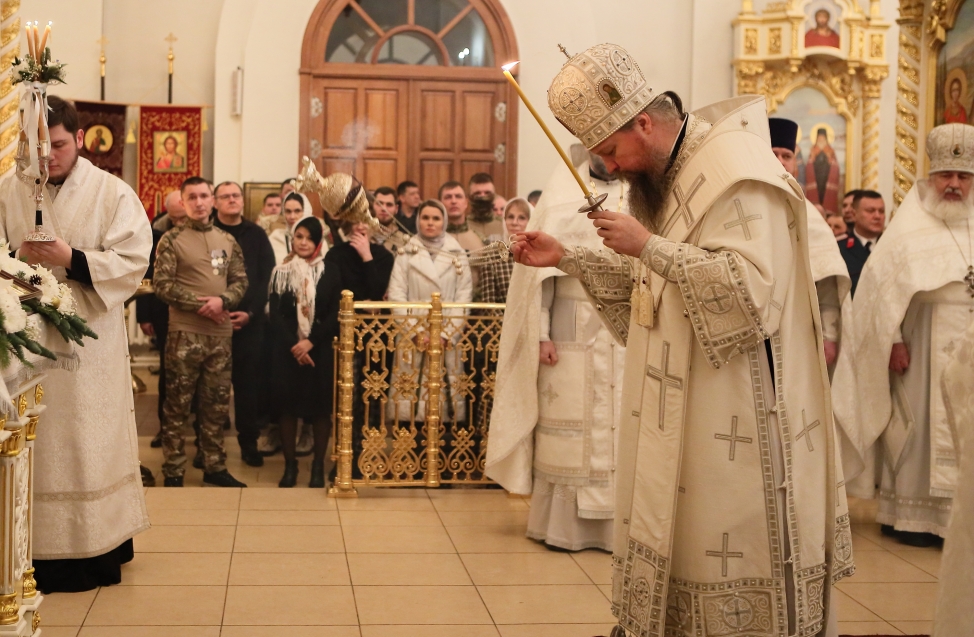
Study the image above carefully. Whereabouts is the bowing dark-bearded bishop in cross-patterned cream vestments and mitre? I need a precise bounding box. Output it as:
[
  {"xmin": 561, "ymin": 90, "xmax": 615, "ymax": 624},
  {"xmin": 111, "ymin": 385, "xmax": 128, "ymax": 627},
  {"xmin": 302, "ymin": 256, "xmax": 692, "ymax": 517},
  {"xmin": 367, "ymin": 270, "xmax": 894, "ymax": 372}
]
[{"xmin": 514, "ymin": 44, "xmax": 854, "ymax": 637}]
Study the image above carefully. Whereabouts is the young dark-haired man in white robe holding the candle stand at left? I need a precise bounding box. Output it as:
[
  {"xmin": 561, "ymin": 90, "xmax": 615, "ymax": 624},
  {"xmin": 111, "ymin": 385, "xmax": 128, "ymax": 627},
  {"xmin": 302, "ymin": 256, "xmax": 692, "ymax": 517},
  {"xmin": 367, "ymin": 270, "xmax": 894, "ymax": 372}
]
[{"xmin": 0, "ymin": 96, "xmax": 152, "ymax": 592}]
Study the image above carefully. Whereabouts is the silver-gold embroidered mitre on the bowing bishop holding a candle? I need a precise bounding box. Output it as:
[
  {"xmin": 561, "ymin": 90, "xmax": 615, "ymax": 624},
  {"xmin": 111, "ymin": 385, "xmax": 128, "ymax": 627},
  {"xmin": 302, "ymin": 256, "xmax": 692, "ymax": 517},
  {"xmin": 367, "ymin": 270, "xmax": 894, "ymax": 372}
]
[{"xmin": 548, "ymin": 44, "xmax": 655, "ymax": 150}]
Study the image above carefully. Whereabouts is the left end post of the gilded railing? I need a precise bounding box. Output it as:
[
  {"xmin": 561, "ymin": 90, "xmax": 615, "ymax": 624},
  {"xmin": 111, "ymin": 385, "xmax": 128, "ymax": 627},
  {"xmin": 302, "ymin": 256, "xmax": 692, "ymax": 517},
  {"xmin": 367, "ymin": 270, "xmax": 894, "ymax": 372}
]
[{"xmin": 328, "ymin": 290, "xmax": 358, "ymax": 498}]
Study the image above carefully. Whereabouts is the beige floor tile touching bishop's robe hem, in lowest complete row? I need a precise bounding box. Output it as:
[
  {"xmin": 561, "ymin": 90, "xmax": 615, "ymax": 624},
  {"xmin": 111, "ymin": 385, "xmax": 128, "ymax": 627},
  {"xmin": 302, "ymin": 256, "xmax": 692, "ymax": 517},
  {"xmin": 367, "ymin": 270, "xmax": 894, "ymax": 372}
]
[{"xmin": 477, "ymin": 584, "xmax": 612, "ymax": 625}]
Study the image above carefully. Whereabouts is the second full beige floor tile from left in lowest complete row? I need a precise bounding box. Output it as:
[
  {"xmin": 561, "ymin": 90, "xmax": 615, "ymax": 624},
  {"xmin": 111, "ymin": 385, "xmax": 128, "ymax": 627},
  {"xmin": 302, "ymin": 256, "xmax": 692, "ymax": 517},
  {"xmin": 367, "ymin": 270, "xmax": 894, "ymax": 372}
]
[{"xmin": 223, "ymin": 586, "xmax": 358, "ymax": 626}]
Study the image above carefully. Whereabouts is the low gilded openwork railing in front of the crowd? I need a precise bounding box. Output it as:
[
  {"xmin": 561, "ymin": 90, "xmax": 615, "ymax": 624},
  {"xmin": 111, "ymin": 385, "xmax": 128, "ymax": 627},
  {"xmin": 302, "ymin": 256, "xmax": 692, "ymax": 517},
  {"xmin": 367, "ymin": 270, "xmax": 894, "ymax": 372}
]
[{"xmin": 329, "ymin": 291, "xmax": 504, "ymax": 497}]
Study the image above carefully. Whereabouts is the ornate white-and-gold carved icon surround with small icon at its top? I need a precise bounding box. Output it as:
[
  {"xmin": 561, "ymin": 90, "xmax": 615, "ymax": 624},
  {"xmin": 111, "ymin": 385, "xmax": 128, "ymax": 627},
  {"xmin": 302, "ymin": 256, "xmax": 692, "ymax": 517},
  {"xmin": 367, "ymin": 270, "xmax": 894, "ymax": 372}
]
[{"xmin": 734, "ymin": 0, "xmax": 890, "ymax": 204}]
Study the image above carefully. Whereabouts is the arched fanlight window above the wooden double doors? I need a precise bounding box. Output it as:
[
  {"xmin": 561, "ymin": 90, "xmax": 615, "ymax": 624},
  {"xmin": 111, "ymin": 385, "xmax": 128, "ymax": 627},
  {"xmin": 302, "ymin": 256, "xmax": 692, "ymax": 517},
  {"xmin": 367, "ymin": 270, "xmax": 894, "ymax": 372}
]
[{"xmin": 324, "ymin": 0, "xmax": 495, "ymax": 67}]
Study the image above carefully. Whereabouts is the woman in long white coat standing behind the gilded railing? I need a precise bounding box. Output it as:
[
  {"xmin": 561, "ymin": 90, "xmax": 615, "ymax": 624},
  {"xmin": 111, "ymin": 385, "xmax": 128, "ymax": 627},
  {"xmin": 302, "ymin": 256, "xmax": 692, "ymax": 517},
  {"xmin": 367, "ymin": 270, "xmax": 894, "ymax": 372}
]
[{"xmin": 387, "ymin": 199, "xmax": 473, "ymax": 427}]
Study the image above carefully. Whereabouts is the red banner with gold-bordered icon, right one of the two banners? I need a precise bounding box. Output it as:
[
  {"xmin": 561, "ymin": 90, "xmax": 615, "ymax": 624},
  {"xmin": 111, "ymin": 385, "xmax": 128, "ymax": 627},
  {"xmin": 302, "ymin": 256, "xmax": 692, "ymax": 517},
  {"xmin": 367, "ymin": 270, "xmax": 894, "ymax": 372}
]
[{"xmin": 138, "ymin": 106, "xmax": 203, "ymax": 219}]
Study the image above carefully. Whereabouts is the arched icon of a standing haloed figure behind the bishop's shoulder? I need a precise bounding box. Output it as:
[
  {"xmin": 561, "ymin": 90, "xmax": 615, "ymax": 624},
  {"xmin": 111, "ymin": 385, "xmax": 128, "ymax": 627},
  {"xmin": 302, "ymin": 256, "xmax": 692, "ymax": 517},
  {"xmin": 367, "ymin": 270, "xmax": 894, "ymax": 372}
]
[{"xmin": 774, "ymin": 87, "xmax": 846, "ymax": 214}]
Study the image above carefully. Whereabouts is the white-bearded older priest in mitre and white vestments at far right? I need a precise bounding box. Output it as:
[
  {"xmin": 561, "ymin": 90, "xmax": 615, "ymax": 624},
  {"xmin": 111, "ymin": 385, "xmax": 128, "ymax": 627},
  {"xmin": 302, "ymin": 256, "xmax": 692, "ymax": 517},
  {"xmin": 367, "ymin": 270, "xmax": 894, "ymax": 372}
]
[{"xmin": 852, "ymin": 124, "xmax": 974, "ymax": 546}]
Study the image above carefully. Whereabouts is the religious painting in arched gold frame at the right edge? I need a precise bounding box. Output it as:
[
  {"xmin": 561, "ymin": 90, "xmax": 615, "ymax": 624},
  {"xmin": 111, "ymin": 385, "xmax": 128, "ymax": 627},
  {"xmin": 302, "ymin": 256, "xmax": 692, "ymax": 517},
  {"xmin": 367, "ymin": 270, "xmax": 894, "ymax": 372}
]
[{"xmin": 934, "ymin": 2, "xmax": 974, "ymax": 125}]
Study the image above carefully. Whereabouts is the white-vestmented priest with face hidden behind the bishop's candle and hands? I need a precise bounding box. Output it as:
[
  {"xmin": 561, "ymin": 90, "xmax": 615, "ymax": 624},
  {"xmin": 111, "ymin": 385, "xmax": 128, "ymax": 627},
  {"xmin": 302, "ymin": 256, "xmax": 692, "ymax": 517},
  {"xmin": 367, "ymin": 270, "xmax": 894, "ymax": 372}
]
[{"xmin": 487, "ymin": 152, "xmax": 625, "ymax": 551}]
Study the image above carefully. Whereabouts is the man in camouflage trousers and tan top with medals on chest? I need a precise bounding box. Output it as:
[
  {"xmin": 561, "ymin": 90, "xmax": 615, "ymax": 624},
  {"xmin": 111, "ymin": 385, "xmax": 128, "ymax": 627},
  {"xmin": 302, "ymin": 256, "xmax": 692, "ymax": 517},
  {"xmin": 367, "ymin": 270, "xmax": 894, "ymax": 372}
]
[{"xmin": 152, "ymin": 177, "xmax": 247, "ymax": 487}]
